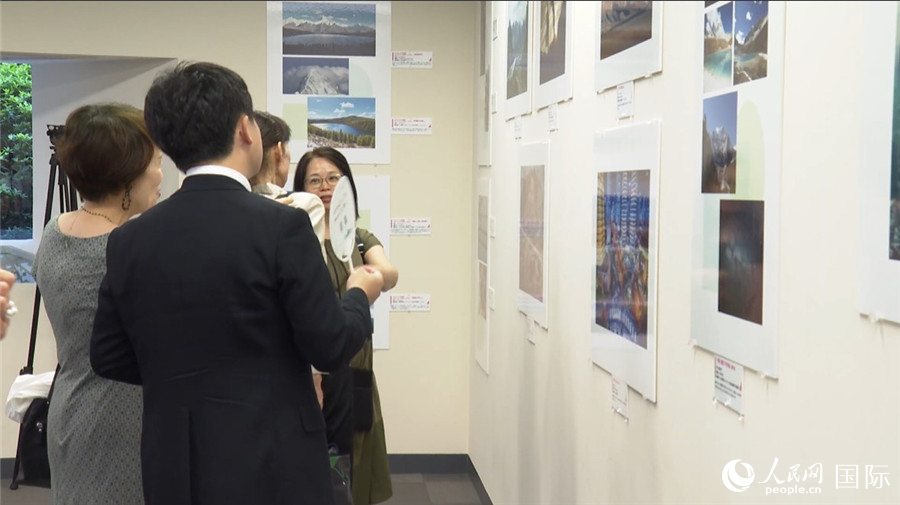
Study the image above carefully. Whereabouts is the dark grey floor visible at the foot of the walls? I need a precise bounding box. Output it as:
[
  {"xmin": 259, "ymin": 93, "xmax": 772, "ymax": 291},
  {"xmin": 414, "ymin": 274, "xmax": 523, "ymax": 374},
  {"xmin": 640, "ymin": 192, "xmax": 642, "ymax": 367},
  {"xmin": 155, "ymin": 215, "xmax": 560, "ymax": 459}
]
[{"xmin": 0, "ymin": 473, "xmax": 490, "ymax": 505}]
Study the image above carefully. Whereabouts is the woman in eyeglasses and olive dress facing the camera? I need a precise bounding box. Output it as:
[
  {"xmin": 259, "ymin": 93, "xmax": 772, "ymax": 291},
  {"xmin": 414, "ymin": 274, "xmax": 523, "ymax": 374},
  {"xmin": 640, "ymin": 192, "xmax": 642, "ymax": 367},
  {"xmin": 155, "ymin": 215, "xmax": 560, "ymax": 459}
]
[{"xmin": 294, "ymin": 147, "xmax": 398, "ymax": 505}]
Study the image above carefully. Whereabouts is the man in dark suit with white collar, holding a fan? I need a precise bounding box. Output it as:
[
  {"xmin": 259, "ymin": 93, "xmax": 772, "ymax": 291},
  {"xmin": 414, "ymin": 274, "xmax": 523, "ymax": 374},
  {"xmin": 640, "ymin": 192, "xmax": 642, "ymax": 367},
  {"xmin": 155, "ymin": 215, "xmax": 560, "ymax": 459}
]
[{"xmin": 91, "ymin": 63, "xmax": 383, "ymax": 505}]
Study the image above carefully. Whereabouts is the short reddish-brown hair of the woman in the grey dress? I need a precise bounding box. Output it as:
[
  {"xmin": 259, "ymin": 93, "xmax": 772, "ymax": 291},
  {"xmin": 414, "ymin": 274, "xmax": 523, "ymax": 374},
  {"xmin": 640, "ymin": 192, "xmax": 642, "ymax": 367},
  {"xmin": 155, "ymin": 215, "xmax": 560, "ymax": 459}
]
[{"xmin": 56, "ymin": 103, "xmax": 156, "ymax": 202}]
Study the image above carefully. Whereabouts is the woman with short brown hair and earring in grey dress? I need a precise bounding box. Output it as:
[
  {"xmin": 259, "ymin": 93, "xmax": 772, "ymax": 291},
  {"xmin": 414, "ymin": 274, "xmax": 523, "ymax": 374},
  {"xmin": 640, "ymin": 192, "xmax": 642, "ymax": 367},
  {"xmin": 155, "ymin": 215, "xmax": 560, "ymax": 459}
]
[{"xmin": 34, "ymin": 103, "xmax": 162, "ymax": 505}]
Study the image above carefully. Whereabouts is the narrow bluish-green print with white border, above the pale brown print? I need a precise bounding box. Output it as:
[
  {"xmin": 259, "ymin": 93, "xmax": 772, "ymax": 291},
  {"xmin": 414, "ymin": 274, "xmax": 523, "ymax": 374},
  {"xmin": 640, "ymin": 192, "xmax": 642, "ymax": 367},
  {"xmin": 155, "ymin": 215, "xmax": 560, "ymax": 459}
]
[{"xmin": 503, "ymin": 2, "xmax": 534, "ymax": 119}]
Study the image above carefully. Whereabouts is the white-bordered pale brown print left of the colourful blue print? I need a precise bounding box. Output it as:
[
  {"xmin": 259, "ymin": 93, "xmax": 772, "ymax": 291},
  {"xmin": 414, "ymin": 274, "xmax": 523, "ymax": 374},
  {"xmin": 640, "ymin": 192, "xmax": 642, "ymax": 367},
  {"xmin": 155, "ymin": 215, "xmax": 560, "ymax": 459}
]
[{"xmin": 516, "ymin": 142, "xmax": 550, "ymax": 328}]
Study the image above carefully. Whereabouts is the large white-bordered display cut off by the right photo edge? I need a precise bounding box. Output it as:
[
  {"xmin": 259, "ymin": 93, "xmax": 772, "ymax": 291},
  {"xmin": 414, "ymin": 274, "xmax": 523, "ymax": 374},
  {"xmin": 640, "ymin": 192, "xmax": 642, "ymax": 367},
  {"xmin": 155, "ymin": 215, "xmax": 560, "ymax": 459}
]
[{"xmin": 857, "ymin": 2, "xmax": 900, "ymax": 324}]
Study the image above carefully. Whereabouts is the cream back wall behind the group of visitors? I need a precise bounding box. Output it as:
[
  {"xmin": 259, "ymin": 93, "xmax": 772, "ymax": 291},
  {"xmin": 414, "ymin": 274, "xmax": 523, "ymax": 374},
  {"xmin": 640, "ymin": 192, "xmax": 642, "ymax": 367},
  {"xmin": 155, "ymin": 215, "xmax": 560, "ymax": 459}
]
[{"xmin": 0, "ymin": 2, "xmax": 476, "ymax": 458}]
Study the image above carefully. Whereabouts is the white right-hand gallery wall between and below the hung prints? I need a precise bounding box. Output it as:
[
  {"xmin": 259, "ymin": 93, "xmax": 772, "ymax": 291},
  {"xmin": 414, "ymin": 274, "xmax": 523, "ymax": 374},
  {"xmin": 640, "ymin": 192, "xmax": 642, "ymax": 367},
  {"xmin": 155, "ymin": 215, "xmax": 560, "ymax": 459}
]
[{"xmin": 469, "ymin": 2, "xmax": 900, "ymax": 505}]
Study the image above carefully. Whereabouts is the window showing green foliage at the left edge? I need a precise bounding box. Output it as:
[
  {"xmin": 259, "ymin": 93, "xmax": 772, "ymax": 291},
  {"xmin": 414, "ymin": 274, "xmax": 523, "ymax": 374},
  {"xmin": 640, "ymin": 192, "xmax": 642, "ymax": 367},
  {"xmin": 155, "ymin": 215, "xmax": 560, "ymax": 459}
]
[{"xmin": 0, "ymin": 62, "xmax": 33, "ymax": 240}]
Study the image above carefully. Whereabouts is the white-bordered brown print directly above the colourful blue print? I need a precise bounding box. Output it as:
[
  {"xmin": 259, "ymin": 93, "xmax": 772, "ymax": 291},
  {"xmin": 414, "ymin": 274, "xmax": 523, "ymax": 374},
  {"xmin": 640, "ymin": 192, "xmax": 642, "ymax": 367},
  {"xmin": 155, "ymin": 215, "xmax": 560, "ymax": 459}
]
[{"xmin": 594, "ymin": 1, "xmax": 663, "ymax": 93}]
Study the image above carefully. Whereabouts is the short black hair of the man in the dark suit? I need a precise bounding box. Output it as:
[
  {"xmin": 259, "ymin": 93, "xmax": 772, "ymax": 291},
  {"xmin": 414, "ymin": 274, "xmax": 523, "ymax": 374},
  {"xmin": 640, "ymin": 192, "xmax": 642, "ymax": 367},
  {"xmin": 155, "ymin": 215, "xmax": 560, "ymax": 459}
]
[{"xmin": 144, "ymin": 62, "xmax": 253, "ymax": 171}]
